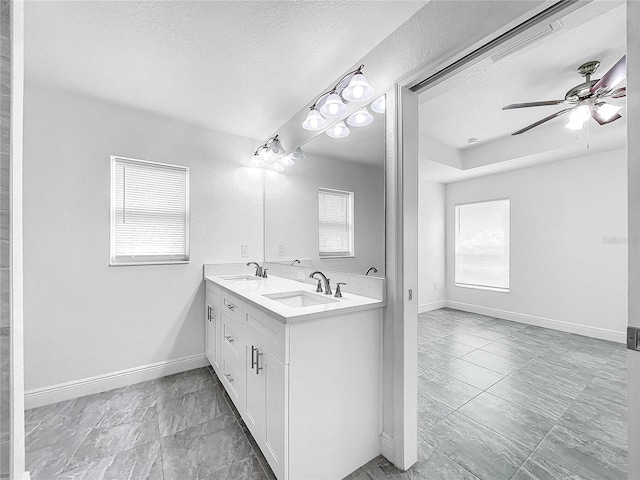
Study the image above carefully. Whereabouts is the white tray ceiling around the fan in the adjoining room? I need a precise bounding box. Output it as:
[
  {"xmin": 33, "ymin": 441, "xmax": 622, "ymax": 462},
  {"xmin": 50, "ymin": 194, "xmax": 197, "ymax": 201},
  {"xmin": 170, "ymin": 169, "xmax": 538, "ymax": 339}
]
[{"xmin": 419, "ymin": 1, "xmax": 626, "ymax": 181}]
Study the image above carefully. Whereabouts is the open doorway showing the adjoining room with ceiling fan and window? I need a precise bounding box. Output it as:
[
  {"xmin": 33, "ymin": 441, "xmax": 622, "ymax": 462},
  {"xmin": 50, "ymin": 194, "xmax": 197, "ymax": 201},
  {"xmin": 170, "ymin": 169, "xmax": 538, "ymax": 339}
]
[{"xmin": 413, "ymin": 2, "xmax": 628, "ymax": 480}]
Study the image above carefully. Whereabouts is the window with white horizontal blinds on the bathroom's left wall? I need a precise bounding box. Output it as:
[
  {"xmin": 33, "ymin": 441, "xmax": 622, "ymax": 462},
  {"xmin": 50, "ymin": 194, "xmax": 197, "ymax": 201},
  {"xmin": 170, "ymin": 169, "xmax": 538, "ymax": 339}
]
[{"xmin": 110, "ymin": 156, "xmax": 189, "ymax": 265}]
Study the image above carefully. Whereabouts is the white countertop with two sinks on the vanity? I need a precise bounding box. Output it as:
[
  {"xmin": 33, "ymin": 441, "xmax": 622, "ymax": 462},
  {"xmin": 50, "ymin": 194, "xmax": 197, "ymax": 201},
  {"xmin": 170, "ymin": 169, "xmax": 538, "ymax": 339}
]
[{"xmin": 204, "ymin": 274, "xmax": 386, "ymax": 323}]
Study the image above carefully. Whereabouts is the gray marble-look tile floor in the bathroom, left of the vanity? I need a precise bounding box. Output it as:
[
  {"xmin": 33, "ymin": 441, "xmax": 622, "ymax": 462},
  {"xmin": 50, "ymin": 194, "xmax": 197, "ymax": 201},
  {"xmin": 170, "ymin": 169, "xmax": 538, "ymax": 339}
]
[{"xmin": 25, "ymin": 367, "xmax": 275, "ymax": 480}]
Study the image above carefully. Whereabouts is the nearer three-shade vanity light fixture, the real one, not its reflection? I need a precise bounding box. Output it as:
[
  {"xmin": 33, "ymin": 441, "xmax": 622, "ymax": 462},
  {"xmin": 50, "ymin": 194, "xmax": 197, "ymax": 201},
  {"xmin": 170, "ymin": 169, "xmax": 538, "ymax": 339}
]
[{"xmin": 302, "ymin": 65, "xmax": 374, "ymax": 131}]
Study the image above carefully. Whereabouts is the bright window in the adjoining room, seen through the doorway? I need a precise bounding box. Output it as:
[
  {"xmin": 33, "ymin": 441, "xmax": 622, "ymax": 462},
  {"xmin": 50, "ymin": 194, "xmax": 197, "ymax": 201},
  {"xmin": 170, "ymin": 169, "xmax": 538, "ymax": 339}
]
[{"xmin": 455, "ymin": 198, "xmax": 510, "ymax": 292}]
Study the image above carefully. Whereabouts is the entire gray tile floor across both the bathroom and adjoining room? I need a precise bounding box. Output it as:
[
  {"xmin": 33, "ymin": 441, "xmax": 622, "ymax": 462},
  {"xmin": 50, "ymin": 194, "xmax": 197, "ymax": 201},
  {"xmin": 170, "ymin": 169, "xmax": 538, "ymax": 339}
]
[{"xmin": 25, "ymin": 309, "xmax": 627, "ymax": 480}]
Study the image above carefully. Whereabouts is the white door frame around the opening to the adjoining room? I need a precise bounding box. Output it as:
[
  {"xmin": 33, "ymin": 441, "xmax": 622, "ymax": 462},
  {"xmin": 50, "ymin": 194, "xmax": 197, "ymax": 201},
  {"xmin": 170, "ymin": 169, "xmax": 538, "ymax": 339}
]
[{"xmin": 393, "ymin": 0, "xmax": 640, "ymax": 472}]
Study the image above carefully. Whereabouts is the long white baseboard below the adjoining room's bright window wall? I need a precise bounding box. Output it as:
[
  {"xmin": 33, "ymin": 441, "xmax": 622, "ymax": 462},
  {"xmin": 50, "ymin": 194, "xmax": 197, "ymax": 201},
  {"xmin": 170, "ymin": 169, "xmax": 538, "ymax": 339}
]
[{"xmin": 445, "ymin": 300, "xmax": 627, "ymax": 343}]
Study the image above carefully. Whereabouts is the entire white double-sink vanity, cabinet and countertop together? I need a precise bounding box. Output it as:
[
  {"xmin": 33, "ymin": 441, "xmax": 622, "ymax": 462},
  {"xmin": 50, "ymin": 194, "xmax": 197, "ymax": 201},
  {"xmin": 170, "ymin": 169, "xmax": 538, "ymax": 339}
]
[{"xmin": 204, "ymin": 265, "xmax": 385, "ymax": 480}]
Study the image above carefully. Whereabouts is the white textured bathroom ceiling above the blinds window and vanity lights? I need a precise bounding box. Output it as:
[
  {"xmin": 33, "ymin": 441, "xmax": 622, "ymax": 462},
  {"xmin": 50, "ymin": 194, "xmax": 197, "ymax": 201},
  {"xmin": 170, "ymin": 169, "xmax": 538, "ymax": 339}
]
[{"xmin": 25, "ymin": 0, "xmax": 426, "ymax": 139}]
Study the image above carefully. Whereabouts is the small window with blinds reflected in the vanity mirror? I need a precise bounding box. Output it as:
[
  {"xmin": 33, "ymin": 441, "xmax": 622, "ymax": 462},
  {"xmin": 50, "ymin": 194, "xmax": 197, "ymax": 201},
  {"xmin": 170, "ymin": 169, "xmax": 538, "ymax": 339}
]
[{"xmin": 318, "ymin": 188, "xmax": 354, "ymax": 257}]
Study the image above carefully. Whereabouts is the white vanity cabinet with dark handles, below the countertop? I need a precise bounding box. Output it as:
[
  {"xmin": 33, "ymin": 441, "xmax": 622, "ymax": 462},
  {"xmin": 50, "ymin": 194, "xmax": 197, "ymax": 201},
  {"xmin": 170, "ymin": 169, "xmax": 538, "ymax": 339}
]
[{"xmin": 207, "ymin": 281, "xmax": 382, "ymax": 480}]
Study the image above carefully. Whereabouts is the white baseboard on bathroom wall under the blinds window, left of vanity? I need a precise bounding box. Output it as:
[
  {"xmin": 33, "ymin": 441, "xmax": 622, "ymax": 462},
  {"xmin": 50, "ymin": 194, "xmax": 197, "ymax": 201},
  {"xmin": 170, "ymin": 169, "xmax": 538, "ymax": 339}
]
[{"xmin": 24, "ymin": 354, "xmax": 209, "ymax": 410}]
